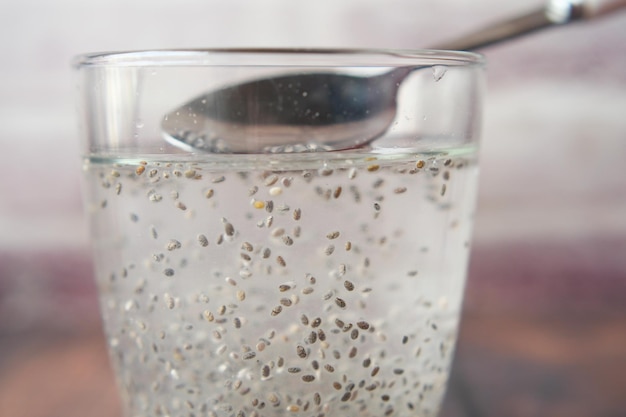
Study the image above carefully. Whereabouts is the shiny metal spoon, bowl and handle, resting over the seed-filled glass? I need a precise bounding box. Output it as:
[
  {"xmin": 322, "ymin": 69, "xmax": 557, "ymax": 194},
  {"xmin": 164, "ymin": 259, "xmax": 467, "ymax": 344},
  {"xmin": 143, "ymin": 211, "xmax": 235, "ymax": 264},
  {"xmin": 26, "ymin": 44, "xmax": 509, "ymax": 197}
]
[{"xmin": 162, "ymin": 0, "xmax": 626, "ymax": 153}]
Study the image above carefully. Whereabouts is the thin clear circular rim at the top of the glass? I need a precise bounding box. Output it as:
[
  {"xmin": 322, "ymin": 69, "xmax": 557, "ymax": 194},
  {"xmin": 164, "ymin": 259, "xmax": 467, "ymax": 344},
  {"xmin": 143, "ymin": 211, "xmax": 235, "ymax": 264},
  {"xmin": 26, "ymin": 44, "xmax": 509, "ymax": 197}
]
[{"xmin": 72, "ymin": 48, "xmax": 486, "ymax": 69}]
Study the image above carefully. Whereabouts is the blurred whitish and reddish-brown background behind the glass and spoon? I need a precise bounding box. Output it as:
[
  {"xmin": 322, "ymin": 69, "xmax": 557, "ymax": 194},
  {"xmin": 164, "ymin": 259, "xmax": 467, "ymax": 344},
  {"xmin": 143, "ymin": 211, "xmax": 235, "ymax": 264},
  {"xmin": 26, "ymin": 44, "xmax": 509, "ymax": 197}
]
[{"xmin": 0, "ymin": 0, "xmax": 626, "ymax": 417}]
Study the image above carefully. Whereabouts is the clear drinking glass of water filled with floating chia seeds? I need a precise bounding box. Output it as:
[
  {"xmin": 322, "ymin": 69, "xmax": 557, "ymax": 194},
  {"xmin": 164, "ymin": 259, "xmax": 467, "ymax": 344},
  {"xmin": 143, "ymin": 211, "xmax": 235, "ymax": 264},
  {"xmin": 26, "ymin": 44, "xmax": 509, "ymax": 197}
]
[{"xmin": 75, "ymin": 50, "xmax": 484, "ymax": 417}]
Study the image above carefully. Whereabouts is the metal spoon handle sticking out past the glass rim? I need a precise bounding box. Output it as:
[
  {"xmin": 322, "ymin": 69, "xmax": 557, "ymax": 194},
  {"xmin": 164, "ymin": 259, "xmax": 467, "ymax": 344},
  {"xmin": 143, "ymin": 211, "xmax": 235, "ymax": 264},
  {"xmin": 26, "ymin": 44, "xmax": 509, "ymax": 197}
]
[{"xmin": 435, "ymin": 0, "xmax": 626, "ymax": 50}]
